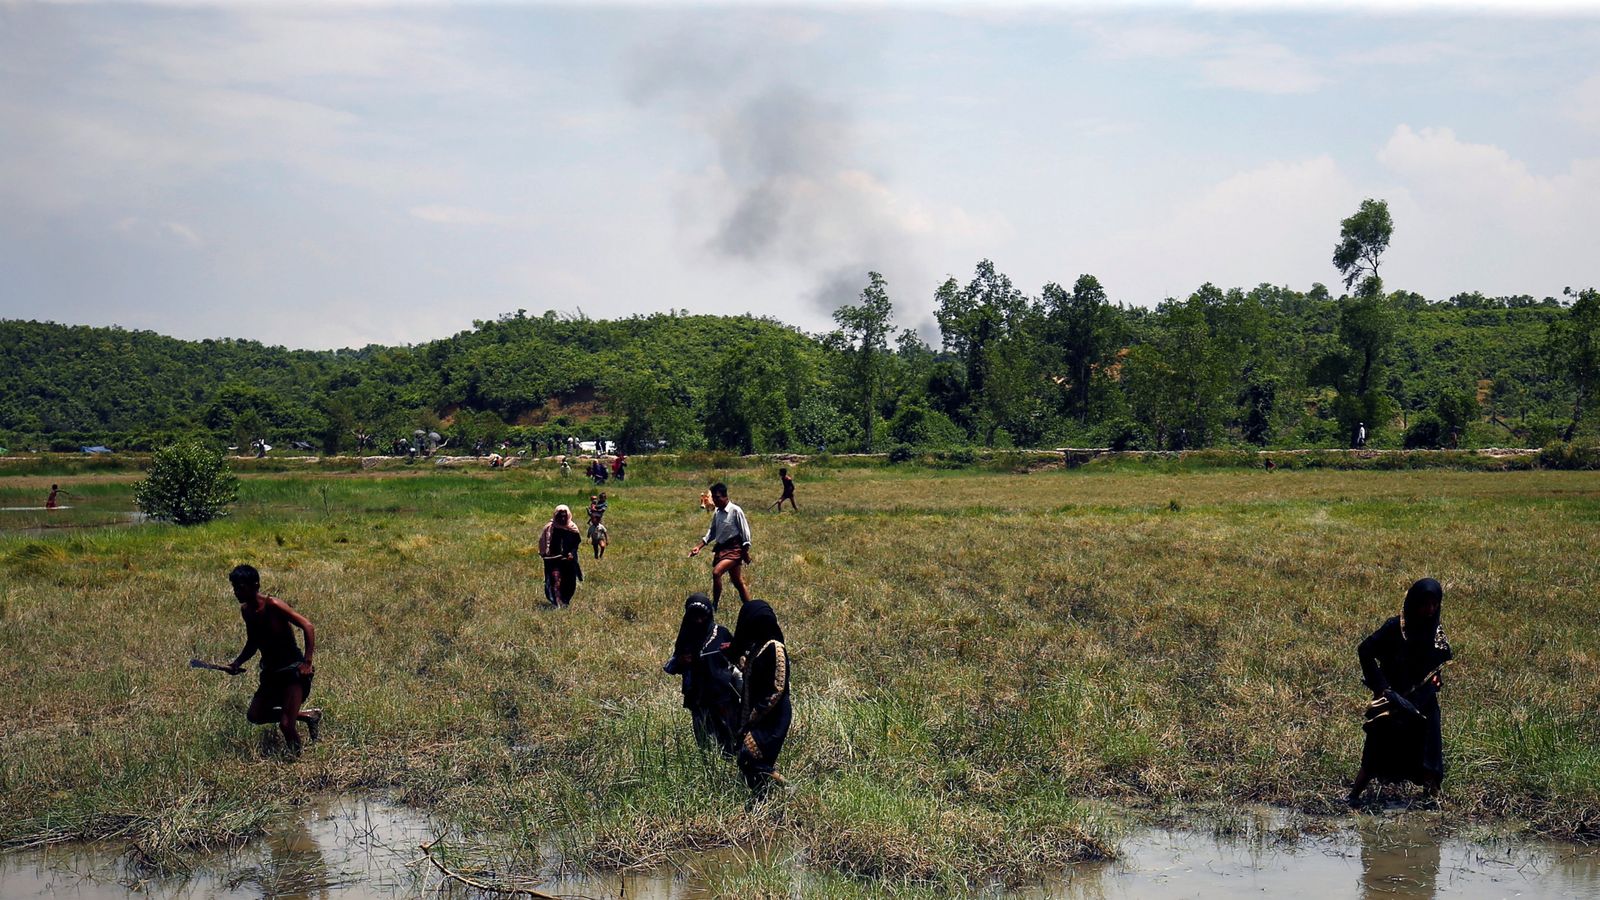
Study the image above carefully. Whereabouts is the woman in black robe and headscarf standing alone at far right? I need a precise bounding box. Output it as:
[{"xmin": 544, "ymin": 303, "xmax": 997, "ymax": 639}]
[{"xmin": 1349, "ymin": 578, "xmax": 1451, "ymax": 806}]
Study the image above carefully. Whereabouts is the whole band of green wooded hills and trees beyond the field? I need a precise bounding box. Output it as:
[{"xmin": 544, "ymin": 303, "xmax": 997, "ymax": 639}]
[{"xmin": 0, "ymin": 273, "xmax": 1600, "ymax": 452}]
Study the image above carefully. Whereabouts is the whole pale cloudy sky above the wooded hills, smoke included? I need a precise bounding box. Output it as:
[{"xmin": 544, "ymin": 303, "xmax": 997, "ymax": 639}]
[{"xmin": 0, "ymin": 0, "xmax": 1600, "ymax": 349}]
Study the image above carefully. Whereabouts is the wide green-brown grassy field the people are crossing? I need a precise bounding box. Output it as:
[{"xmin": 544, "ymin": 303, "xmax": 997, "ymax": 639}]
[{"xmin": 0, "ymin": 461, "xmax": 1600, "ymax": 895}]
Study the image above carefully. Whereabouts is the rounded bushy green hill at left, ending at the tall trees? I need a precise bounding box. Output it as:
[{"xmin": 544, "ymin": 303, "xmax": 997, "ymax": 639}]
[{"xmin": 0, "ymin": 312, "xmax": 821, "ymax": 450}]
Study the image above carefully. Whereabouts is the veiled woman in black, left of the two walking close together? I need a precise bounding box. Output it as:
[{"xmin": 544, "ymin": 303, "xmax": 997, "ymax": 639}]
[{"xmin": 662, "ymin": 594, "xmax": 739, "ymax": 756}]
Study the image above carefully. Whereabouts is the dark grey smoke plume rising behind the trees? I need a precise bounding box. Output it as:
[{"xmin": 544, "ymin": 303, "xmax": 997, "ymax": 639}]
[{"xmin": 627, "ymin": 21, "xmax": 917, "ymax": 312}]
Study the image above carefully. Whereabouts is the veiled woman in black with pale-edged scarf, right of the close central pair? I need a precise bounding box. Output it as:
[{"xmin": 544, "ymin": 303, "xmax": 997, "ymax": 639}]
[{"xmin": 733, "ymin": 601, "xmax": 794, "ymax": 796}]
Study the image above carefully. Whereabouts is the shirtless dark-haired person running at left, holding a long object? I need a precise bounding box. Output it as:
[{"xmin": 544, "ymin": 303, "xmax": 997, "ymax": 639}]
[{"xmin": 216, "ymin": 565, "xmax": 322, "ymax": 753}]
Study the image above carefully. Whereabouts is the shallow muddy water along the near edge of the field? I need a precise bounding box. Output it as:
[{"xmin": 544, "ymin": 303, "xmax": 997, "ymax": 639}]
[{"xmin": 0, "ymin": 801, "xmax": 1600, "ymax": 900}]
